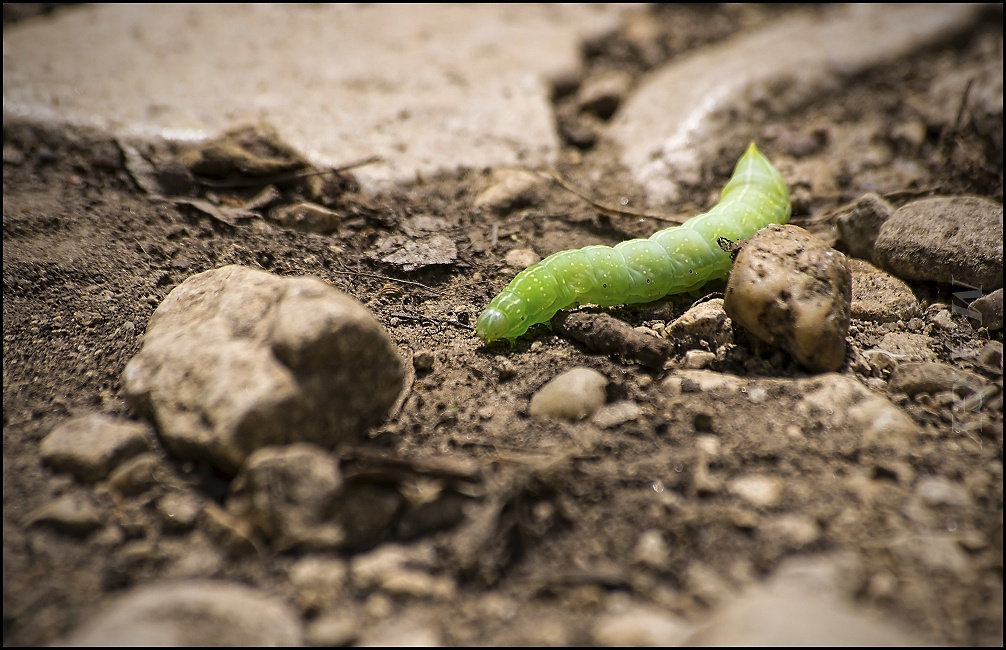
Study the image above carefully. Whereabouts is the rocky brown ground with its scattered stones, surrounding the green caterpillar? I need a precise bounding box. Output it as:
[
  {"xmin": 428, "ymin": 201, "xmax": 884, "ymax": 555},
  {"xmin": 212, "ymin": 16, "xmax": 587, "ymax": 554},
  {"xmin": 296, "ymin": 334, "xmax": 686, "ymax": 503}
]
[{"xmin": 3, "ymin": 5, "xmax": 1003, "ymax": 645}]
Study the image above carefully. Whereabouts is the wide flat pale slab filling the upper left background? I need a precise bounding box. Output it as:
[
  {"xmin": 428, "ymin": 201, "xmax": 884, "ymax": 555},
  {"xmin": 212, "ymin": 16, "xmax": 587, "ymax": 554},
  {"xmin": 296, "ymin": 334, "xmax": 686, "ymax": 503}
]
[{"xmin": 3, "ymin": 4, "xmax": 623, "ymax": 184}]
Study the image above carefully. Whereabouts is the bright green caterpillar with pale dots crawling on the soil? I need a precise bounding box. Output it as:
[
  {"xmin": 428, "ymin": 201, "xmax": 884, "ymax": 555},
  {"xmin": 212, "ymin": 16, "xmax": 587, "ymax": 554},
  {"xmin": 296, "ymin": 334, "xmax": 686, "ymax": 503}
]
[{"xmin": 475, "ymin": 143, "xmax": 791, "ymax": 342}]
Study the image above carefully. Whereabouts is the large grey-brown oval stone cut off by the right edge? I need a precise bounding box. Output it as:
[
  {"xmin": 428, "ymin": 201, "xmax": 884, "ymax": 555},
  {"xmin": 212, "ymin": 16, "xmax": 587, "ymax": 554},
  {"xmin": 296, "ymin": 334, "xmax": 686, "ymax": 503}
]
[{"xmin": 873, "ymin": 196, "xmax": 1003, "ymax": 291}]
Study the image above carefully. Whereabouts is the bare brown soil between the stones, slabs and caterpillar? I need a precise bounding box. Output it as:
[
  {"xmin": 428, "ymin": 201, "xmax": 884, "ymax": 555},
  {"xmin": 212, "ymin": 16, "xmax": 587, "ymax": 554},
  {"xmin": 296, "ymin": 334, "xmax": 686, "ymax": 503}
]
[{"xmin": 3, "ymin": 6, "xmax": 1003, "ymax": 645}]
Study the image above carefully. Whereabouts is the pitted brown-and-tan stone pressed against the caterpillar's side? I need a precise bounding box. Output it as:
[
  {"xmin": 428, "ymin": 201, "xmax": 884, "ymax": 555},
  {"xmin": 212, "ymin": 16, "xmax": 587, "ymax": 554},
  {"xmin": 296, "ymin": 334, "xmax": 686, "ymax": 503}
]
[{"xmin": 723, "ymin": 225, "xmax": 852, "ymax": 372}]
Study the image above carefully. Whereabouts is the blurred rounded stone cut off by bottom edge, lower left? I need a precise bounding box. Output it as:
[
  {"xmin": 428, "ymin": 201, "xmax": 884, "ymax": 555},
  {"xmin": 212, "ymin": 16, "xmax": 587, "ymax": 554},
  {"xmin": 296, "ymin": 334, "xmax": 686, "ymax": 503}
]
[{"xmin": 63, "ymin": 581, "xmax": 303, "ymax": 647}]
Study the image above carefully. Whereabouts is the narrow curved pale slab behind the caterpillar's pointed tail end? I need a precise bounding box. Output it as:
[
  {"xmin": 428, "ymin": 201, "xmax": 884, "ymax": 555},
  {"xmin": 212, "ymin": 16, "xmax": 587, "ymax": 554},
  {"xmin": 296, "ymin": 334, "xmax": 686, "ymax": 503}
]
[{"xmin": 608, "ymin": 4, "xmax": 983, "ymax": 204}]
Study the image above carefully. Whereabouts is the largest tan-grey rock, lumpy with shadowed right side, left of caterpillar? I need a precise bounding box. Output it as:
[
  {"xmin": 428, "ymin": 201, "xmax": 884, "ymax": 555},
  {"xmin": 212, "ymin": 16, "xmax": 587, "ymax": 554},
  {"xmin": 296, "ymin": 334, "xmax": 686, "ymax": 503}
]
[{"xmin": 123, "ymin": 266, "xmax": 403, "ymax": 473}]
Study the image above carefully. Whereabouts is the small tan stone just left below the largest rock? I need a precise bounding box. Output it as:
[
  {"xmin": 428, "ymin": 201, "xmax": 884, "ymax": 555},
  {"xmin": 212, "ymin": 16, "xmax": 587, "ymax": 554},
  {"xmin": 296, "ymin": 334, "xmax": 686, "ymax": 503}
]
[{"xmin": 39, "ymin": 414, "xmax": 154, "ymax": 482}]
